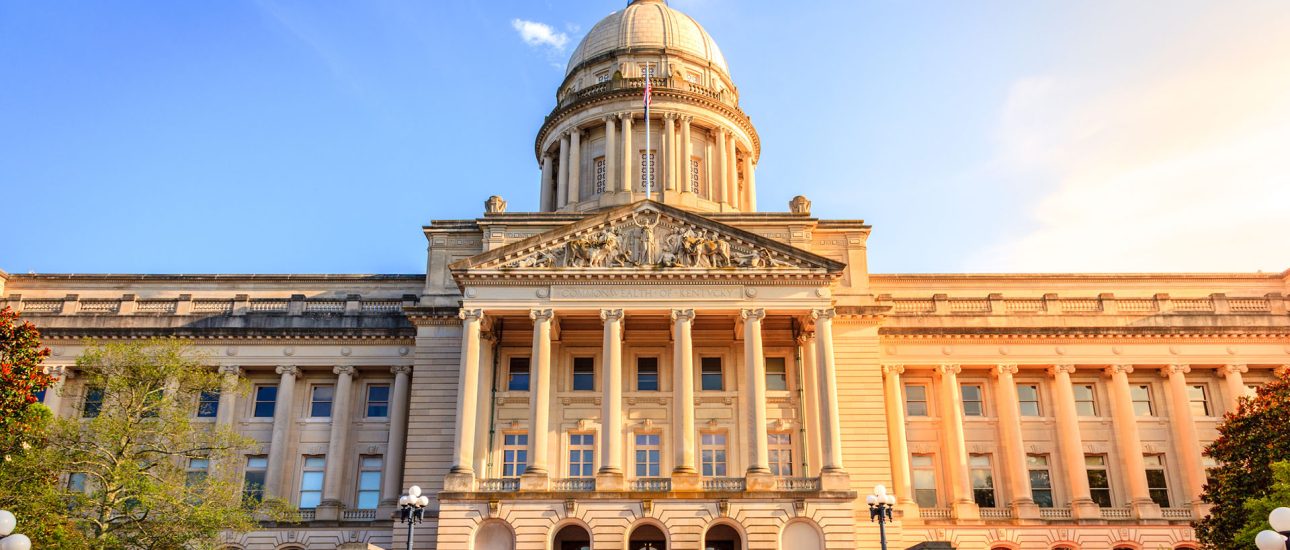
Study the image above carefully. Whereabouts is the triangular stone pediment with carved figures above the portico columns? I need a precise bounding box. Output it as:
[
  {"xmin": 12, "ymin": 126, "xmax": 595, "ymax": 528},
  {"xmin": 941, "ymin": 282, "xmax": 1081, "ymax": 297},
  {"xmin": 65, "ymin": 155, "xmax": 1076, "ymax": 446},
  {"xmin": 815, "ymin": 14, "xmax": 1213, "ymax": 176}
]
[{"xmin": 449, "ymin": 200, "xmax": 845, "ymax": 279}]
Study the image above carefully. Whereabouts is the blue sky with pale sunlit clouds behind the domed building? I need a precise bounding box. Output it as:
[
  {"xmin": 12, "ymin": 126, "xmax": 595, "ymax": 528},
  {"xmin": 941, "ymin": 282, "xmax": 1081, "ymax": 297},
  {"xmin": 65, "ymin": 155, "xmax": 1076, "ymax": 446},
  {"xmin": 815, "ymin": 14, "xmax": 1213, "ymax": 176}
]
[{"xmin": 0, "ymin": 0, "xmax": 1290, "ymax": 272}]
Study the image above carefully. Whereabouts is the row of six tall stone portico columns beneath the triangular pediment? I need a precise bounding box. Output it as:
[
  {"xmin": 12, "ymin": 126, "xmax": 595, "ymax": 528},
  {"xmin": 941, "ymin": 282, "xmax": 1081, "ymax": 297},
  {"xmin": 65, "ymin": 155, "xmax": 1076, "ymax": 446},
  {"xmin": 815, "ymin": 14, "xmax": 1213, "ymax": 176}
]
[{"xmin": 449, "ymin": 309, "xmax": 845, "ymax": 491}]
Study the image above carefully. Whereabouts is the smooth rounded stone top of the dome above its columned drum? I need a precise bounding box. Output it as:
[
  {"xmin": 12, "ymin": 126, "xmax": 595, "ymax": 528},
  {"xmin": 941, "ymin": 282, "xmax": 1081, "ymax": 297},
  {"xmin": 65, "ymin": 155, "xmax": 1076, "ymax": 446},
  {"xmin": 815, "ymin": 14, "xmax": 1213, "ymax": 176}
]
[{"xmin": 565, "ymin": 0, "xmax": 730, "ymax": 77}]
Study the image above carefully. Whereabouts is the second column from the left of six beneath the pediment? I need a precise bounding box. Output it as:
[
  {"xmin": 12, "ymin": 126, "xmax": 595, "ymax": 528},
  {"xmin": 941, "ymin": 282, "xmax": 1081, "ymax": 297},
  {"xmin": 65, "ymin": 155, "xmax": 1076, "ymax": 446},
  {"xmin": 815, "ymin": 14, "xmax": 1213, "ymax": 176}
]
[{"xmin": 520, "ymin": 310, "xmax": 555, "ymax": 491}]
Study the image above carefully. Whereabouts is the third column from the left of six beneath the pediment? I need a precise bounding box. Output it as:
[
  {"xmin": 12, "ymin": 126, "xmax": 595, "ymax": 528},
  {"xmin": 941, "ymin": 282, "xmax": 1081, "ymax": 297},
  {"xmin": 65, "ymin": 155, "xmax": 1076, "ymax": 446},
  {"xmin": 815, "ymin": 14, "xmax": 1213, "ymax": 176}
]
[{"xmin": 596, "ymin": 310, "xmax": 623, "ymax": 491}]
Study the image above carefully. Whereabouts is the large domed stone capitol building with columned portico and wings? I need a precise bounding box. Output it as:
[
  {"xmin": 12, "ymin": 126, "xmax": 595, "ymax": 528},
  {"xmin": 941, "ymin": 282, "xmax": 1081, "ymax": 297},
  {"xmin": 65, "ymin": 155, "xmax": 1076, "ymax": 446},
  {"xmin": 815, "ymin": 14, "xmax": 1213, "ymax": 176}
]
[{"xmin": 0, "ymin": 0, "xmax": 1290, "ymax": 550}]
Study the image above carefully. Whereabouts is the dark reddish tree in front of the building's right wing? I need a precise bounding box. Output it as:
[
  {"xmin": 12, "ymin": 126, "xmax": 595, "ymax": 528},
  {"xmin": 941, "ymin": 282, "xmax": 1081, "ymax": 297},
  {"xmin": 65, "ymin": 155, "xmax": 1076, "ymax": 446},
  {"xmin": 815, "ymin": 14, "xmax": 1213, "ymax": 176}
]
[{"xmin": 1196, "ymin": 373, "xmax": 1290, "ymax": 549}]
